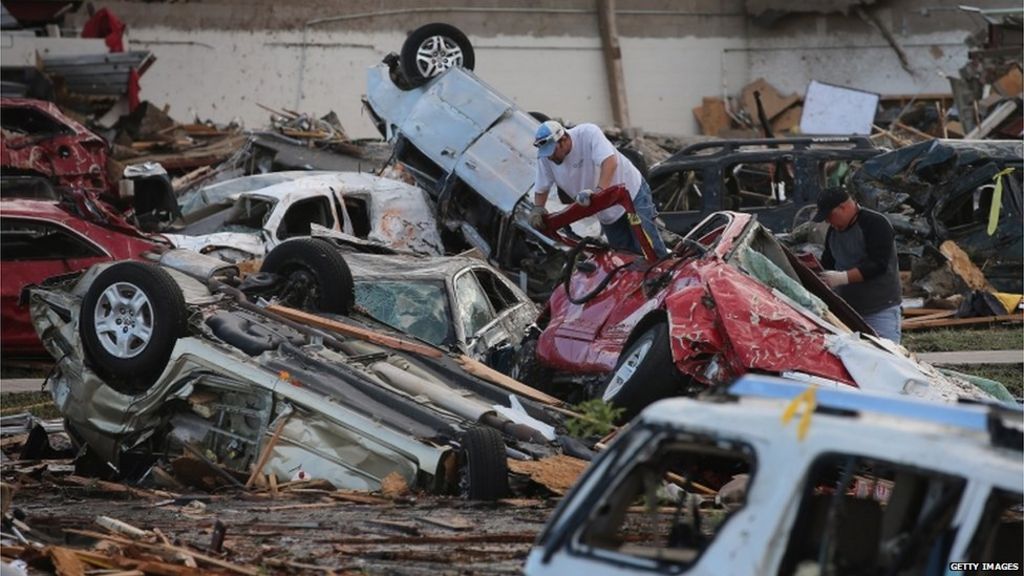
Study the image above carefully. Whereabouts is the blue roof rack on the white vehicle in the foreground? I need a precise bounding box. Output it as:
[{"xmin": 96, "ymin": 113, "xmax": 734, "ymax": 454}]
[{"xmin": 728, "ymin": 374, "xmax": 1024, "ymax": 438}]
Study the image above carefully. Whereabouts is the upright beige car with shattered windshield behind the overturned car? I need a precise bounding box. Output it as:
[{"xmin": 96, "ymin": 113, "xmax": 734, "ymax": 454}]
[{"xmin": 345, "ymin": 251, "xmax": 538, "ymax": 372}]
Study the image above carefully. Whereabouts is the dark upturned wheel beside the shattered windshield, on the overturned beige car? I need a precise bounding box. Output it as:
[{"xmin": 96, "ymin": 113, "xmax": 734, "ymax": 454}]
[{"xmin": 260, "ymin": 238, "xmax": 355, "ymax": 315}]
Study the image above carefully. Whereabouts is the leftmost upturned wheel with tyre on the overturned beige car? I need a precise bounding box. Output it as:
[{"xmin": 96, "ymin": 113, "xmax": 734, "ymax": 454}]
[{"xmin": 79, "ymin": 262, "xmax": 187, "ymax": 394}]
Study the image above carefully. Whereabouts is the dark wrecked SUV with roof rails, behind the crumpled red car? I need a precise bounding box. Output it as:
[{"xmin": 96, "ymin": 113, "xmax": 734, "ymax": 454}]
[{"xmin": 647, "ymin": 136, "xmax": 884, "ymax": 234}]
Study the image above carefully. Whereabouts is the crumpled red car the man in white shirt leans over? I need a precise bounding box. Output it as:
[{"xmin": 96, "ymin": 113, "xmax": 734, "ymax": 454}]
[{"xmin": 517, "ymin": 187, "xmax": 873, "ymax": 418}]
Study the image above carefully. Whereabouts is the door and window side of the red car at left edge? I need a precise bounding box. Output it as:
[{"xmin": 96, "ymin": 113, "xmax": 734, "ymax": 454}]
[{"xmin": 0, "ymin": 217, "xmax": 111, "ymax": 354}]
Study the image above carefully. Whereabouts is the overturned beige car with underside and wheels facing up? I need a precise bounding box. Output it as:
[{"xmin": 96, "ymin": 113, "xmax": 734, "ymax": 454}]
[{"xmin": 31, "ymin": 238, "xmax": 556, "ymax": 499}]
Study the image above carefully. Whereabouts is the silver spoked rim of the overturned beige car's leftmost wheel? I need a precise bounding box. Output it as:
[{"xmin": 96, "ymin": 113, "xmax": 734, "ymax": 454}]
[{"xmin": 93, "ymin": 282, "xmax": 154, "ymax": 360}]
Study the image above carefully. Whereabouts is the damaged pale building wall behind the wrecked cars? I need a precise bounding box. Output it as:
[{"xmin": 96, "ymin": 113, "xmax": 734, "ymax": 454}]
[{"xmin": 59, "ymin": 0, "xmax": 981, "ymax": 137}]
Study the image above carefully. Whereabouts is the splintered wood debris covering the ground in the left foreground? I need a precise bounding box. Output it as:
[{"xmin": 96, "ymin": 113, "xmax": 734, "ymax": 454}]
[{"xmin": 0, "ymin": 457, "xmax": 561, "ymax": 576}]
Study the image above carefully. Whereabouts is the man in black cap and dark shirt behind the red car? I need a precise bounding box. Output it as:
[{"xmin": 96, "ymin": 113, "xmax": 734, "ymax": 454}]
[{"xmin": 814, "ymin": 188, "xmax": 902, "ymax": 343}]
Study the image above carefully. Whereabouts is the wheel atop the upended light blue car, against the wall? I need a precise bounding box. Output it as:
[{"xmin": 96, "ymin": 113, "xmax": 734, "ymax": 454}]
[{"xmin": 400, "ymin": 23, "xmax": 475, "ymax": 87}]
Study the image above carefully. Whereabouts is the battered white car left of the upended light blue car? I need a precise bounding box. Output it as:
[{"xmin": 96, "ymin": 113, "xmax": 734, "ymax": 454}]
[{"xmin": 163, "ymin": 171, "xmax": 443, "ymax": 258}]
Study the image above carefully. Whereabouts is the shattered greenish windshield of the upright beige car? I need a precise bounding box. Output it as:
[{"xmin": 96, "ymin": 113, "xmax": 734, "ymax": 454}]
[{"xmin": 355, "ymin": 281, "xmax": 452, "ymax": 345}]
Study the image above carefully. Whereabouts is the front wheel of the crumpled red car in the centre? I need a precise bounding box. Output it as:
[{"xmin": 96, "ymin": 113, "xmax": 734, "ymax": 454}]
[{"xmin": 601, "ymin": 322, "xmax": 681, "ymax": 421}]
